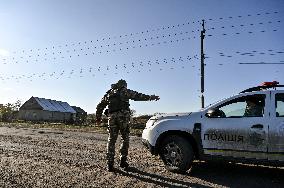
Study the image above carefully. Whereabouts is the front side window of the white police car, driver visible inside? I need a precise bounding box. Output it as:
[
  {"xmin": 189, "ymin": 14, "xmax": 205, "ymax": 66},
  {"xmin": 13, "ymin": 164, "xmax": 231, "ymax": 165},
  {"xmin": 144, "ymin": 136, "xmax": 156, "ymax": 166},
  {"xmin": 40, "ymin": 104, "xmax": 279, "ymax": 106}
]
[{"xmin": 218, "ymin": 94, "xmax": 265, "ymax": 118}]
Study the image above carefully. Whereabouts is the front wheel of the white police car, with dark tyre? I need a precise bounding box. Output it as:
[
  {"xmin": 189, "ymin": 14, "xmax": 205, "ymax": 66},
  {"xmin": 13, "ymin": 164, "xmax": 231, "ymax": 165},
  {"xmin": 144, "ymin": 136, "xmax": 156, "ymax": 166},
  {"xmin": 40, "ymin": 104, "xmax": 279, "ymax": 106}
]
[{"xmin": 159, "ymin": 135, "xmax": 194, "ymax": 173}]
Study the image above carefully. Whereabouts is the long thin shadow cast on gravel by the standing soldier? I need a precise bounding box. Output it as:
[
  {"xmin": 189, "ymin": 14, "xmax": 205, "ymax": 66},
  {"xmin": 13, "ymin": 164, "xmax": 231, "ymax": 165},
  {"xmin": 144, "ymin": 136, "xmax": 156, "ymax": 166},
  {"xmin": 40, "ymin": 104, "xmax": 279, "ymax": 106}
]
[{"xmin": 115, "ymin": 167, "xmax": 210, "ymax": 187}]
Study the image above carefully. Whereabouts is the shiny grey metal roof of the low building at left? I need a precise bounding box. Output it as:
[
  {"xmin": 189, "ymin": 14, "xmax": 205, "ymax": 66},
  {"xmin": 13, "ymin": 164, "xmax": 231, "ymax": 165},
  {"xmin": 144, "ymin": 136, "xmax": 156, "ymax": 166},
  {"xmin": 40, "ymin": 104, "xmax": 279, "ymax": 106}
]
[{"xmin": 34, "ymin": 97, "xmax": 76, "ymax": 113}]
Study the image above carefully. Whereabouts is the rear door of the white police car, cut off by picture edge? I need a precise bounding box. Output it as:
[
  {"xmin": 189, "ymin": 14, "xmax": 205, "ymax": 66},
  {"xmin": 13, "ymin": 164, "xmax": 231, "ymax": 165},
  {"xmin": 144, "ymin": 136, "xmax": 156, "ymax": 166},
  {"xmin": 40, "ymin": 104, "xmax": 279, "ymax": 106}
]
[{"xmin": 268, "ymin": 91, "xmax": 284, "ymax": 161}]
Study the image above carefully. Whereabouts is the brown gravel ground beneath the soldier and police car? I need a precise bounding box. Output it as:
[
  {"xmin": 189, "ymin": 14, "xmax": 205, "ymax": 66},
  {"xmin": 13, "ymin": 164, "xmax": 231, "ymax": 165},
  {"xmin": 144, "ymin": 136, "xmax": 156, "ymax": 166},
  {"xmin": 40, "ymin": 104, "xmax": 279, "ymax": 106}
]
[{"xmin": 0, "ymin": 127, "xmax": 284, "ymax": 187}]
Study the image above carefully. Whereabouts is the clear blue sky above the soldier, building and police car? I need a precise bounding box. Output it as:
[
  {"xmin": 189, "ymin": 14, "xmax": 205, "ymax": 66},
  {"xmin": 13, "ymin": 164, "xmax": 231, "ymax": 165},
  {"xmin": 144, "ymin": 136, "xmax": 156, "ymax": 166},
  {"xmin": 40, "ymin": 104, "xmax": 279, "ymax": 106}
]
[{"xmin": 0, "ymin": 0, "xmax": 284, "ymax": 114}]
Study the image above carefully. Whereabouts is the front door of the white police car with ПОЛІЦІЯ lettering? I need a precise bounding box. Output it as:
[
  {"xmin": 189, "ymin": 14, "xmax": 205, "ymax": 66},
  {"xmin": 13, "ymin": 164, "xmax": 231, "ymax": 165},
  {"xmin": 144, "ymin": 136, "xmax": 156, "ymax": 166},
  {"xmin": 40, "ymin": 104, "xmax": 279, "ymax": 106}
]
[{"xmin": 201, "ymin": 92, "xmax": 270, "ymax": 159}]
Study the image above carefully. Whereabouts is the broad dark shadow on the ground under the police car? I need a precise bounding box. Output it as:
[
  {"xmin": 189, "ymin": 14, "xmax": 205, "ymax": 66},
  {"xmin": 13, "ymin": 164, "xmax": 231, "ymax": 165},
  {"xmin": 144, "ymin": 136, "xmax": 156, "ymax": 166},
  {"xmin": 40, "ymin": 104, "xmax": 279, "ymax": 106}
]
[{"xmin": 187, "ymin": 162, "xmax": 284, "ymax": 187}]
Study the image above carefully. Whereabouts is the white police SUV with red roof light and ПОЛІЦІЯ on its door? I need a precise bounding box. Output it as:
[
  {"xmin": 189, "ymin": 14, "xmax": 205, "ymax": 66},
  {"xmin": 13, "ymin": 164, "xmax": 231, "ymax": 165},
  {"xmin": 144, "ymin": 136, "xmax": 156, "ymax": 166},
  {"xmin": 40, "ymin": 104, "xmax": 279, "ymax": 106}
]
[{"xmin": 142, "ymin": 81, "xmax": 284, "ymax": 173}]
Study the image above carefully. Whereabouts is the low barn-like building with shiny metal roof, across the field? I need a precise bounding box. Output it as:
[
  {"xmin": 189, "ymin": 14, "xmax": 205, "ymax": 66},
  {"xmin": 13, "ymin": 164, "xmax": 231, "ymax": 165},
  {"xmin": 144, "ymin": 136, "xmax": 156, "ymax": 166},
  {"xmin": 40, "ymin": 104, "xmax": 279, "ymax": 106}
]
[{"xmin": 18, "ymin": 97, "xmax": 76, "ymax": 122}]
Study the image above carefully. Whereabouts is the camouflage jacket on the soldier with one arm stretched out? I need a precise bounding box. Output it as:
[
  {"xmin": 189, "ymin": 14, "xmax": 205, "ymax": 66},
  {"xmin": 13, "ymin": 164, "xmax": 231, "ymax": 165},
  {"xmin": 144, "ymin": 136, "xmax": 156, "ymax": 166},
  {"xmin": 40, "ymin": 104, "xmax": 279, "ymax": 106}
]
[{"xmin": 96, "ymin": 87, "xmax": 152, "ymax": 119}]
